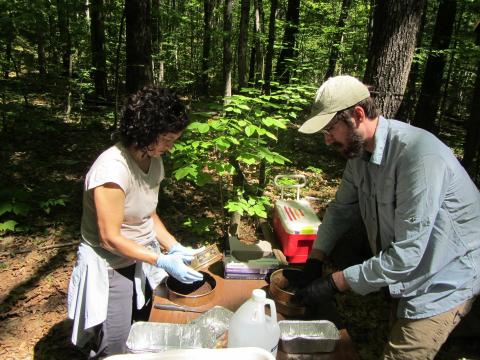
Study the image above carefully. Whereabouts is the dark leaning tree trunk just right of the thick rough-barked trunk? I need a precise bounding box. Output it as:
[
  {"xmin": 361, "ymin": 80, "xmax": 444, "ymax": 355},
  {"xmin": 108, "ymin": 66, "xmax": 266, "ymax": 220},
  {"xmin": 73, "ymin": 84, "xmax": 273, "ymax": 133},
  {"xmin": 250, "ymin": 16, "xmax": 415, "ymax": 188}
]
[{"xmin": 413, "ymin": 0, "xmax": 457, "ymax": 133}]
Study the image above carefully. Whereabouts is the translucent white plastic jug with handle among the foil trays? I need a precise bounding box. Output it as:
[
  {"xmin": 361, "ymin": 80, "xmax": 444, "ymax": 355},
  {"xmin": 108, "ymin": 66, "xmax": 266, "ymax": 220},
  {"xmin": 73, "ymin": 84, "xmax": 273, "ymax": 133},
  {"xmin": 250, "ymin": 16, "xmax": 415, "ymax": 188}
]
[{"xmin": 228, "ymin": 289, "xmax": 280, "ymax": 356}]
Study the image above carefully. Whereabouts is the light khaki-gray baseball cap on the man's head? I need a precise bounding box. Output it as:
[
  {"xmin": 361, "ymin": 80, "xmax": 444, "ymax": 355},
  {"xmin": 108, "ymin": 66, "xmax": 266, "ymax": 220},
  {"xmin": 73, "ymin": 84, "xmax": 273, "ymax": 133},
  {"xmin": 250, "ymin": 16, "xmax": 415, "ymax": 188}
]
[{"xmin": 298, "ymin": 75, "xmax": 370, "ymax": 134}]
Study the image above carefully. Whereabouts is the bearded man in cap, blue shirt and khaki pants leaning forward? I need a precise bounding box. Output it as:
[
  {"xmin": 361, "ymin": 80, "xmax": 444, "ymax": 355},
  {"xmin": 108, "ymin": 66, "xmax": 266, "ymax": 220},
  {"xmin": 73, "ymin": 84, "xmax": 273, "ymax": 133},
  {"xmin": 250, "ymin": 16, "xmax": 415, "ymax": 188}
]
[{"xmin": 299, "ymin": 76, "xmax": 480, "ymax": 359}]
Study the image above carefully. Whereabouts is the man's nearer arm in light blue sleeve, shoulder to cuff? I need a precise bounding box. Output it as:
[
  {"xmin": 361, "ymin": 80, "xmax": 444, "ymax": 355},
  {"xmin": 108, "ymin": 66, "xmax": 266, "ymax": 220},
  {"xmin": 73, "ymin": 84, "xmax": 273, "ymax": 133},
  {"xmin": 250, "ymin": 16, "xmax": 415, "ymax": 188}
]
[{"xmin": 343, "ymin": 153, "xmax": 449, "ymax": 294}]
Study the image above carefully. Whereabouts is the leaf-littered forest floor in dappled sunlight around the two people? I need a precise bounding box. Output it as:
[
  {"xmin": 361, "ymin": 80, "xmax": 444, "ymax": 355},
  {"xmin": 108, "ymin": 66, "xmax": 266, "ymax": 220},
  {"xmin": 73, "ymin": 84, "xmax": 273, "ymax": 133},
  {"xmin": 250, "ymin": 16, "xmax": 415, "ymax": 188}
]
[{"xmin": 0, "ymin": 74, "xmax": 480, "ymax": 360}]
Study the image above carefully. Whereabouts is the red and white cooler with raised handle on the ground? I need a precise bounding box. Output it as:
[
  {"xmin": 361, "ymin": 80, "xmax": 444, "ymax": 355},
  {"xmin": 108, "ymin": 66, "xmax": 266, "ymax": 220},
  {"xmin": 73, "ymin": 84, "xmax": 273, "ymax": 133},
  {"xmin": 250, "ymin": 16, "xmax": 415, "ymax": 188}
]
[{"xmin": 273, "ymin": 175, "xmax": 320, "ymax": 264}]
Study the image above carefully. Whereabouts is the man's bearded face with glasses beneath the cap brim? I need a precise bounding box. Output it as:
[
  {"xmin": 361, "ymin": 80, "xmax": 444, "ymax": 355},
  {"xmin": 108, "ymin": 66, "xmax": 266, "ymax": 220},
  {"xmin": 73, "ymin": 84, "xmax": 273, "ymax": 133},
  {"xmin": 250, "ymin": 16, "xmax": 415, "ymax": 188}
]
[{"xmin": 323, "ymin": 116, "xmax": 365, "ymax": 159}]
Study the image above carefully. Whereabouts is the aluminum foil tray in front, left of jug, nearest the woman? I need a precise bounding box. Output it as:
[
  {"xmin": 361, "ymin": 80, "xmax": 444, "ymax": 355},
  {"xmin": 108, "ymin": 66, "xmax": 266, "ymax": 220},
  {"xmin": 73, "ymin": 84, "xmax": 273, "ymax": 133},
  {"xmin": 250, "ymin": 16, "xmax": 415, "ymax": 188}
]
[{"xmin": 127, "ymin": 321, "xmax": 216, "ymax": 353}]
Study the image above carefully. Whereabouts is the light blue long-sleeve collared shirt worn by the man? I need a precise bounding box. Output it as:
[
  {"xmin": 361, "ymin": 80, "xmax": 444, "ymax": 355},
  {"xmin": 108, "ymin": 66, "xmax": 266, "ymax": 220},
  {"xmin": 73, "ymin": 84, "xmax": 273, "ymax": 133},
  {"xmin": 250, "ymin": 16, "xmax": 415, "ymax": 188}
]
[{"xmin": 313, "ymin": 117, "xmax": 480, "ymax": 318}]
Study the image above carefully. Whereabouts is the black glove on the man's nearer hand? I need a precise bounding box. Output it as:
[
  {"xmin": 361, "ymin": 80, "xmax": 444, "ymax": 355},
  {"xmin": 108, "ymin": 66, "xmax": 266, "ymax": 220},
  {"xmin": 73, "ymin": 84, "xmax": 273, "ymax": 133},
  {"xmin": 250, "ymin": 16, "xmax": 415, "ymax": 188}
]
[{"xmin": 294, "ymin": 274, "xmax": 339, "ymax": 306}]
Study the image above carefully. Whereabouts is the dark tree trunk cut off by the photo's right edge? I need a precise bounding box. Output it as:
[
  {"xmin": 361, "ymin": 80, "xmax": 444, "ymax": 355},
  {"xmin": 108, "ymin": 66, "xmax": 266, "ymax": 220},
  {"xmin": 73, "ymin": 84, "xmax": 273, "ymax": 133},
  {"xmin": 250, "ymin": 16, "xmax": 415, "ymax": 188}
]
[{"xmin": 462, "ymin": 22, "xmax": 480, "ymax": 179}]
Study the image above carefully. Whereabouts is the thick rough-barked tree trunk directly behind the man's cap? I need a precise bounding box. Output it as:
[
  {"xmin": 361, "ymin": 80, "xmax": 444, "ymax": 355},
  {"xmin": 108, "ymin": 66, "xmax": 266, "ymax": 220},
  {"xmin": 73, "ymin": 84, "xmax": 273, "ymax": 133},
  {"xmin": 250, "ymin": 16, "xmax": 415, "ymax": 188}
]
[{"xmin": 364, "ymin": 0, "xmax": 425, "ymax": 117}]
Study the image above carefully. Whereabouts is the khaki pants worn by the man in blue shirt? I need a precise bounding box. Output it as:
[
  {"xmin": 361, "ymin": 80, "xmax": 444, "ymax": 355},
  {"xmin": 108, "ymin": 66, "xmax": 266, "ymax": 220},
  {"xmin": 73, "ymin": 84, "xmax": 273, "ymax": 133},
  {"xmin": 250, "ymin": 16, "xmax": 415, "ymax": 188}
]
[{"xmin": 383, "ymin": 298, "xmax": 475, "ymax": 360}]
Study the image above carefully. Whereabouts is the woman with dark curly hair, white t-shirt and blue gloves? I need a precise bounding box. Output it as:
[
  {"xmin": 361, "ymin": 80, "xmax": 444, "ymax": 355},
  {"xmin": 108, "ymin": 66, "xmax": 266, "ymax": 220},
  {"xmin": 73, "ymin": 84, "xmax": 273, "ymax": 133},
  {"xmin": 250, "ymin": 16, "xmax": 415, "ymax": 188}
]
[{"xmin": 68, "ymin": 86, "xmax": 202, "ymax": 359}]
